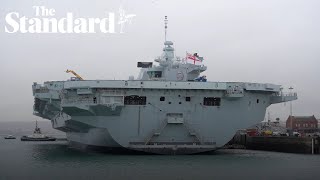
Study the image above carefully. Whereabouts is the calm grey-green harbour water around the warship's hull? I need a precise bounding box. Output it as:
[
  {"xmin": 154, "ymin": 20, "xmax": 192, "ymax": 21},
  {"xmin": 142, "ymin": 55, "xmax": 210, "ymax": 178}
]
[{"xmin": 0, "ymin": 122, "xmax": 320, "ymax": 180}]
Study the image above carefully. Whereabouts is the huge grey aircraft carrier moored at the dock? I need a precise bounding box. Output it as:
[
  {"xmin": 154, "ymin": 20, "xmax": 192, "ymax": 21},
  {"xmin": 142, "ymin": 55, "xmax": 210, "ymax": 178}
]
[{"xmin": 32, "ymin": 19, "xmax": 297, "ymax": 154}]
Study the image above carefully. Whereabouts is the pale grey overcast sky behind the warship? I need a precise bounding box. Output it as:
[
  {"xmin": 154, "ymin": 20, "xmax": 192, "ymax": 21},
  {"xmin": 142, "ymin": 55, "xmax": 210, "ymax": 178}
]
[{"xmin": 0, "ymin": 0, "xmax": 320, "ymax": 121}]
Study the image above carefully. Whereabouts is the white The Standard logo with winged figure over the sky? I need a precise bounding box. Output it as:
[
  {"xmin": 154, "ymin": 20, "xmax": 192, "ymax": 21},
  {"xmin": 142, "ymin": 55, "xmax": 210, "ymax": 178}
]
[{"xmin": 5, "ymin": 6, "xmax": 136, "ymax": 33}]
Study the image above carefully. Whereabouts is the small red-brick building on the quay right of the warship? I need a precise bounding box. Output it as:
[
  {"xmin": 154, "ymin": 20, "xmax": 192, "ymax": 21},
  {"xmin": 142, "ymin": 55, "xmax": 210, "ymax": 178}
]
[{"xmin": 286, "ymin": 115, "xmax": 318, "ymax": 133}]
